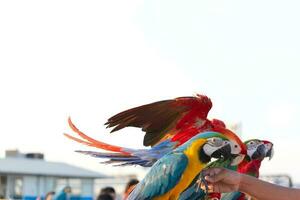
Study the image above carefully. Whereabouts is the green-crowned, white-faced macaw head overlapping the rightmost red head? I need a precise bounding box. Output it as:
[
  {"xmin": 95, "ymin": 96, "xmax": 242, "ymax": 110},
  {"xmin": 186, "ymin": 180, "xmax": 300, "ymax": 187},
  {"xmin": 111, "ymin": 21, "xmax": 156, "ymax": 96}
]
[{"xmin": 245, "ymin": 139, "xmax": 267, "ymax": 160}]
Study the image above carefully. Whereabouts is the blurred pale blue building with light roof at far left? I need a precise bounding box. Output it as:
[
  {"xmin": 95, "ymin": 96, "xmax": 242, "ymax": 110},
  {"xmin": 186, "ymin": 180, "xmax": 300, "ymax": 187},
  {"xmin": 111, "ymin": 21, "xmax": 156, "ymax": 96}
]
[{"xmin": 0, "ymin": 150, "xmax": 109, "ymax": 200}]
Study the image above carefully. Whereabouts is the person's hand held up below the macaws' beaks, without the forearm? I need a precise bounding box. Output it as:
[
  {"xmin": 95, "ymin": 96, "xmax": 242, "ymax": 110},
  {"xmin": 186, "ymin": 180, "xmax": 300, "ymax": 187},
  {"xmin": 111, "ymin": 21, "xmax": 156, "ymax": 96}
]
[{"xmin": 203, "ymin": 168, "xmax": 242, "ymax": 193}]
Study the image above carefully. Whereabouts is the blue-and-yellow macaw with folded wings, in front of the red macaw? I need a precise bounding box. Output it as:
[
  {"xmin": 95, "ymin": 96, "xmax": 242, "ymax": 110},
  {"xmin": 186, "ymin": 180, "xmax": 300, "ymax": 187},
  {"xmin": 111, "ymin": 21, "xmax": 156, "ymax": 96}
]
[{"xmin": 128, "ymin": 132, "xmax": 239, "ymax": 200}]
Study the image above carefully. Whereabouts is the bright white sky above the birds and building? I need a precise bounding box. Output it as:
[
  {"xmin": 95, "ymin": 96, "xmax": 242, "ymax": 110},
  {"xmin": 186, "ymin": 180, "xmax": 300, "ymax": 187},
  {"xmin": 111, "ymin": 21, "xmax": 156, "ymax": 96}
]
[{"xmin": 0, "ymin": 0, "xmax": 300, "ymax": 182}]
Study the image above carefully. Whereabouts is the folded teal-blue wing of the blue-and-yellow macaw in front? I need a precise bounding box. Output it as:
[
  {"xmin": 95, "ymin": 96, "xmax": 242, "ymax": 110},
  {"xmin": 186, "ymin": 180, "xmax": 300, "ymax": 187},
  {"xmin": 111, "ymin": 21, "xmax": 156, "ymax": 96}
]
[{"xmin": 128, "ymin": 152, "xmax": 188, "ymax": 200}]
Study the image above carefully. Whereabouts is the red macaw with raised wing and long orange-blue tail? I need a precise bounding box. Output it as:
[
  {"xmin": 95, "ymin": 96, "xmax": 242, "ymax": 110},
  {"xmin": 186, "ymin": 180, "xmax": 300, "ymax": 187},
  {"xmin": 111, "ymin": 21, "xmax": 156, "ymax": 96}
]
[{"xmin": 65, "ymin": 95, "xmax": 246, "ymax": 167}]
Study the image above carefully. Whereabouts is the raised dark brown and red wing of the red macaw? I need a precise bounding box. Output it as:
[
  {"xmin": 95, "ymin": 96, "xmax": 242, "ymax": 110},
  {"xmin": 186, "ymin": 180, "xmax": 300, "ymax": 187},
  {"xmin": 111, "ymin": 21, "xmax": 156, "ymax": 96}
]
[{"xmin": 105, "ymin": 95, "xmax": 212, "ymax": 146}]
